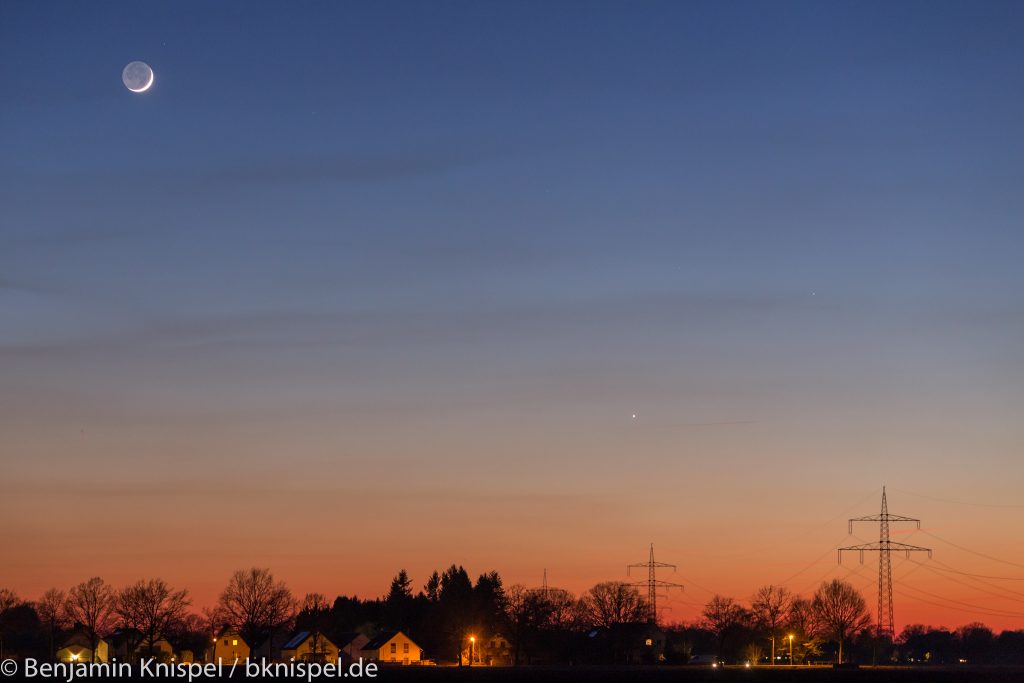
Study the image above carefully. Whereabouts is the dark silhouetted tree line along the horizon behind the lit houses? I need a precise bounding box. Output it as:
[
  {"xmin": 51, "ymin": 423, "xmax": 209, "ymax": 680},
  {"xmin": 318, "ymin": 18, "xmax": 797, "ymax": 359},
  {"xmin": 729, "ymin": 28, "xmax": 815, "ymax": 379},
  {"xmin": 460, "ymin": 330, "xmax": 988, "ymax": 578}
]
[{"xmin": 0, "ymin": 564, "xmax": 1024, "ymax": 665}]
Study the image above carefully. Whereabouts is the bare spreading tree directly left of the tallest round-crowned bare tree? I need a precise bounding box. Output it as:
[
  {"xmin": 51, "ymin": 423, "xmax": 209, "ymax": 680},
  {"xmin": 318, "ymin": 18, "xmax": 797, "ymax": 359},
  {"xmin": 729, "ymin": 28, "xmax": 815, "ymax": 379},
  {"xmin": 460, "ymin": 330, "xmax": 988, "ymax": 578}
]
[{"xmin": 114, "ymin": 579, "xmax": 191, "ymax": 656}]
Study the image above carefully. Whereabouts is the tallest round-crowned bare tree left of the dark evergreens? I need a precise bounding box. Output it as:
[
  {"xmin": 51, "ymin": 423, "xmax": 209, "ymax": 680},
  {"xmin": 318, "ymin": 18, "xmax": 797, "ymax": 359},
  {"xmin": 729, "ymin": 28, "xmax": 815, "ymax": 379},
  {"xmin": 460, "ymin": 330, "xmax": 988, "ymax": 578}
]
[{"xmin": 217, "ymin": 567, "xmax": 298, "ymax": 643}]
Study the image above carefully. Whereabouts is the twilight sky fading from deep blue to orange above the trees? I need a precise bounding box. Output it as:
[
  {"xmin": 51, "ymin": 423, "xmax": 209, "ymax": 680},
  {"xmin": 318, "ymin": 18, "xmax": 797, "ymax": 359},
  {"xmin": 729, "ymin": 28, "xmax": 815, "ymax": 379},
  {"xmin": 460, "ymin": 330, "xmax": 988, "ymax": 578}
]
[{"xmin": 0, "ymin": 2, "xmax": 1024, "ymax": 628}]
